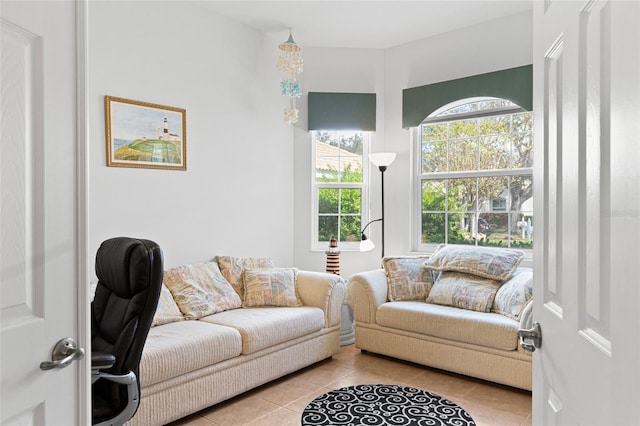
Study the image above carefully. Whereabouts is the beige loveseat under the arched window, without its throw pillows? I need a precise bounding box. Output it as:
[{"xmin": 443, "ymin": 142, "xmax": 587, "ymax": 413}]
[{"xmin": 347, "ymin": 248, "xmax": 533, "ymax": 390}]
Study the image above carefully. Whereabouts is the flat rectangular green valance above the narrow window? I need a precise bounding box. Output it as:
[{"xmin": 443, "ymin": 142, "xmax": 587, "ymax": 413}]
[{"xmin": 309, "ymin": 92, "xmax": 376, "ymax": 131}]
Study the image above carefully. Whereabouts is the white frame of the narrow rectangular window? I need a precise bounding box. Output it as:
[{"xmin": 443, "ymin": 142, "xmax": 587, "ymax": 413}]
[{"xmin": 310, "ymin": 129, "xmax": 373, "ymax": 251}]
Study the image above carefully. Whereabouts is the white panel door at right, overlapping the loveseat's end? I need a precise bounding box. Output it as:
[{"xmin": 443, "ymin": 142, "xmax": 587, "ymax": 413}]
[{"xmin": 533, "ymin": 0, "xmax": 640, "ymax": 426}]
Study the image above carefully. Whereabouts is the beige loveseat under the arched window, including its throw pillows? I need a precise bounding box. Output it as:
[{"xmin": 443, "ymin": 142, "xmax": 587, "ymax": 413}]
[{"xmin": 347, "ymin": 246, "xmax": 533, "ymax": 390}]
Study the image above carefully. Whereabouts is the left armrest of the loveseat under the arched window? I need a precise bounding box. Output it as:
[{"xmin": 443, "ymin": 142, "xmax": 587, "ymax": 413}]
[{"xmin": 347, "ymin": 269, "xmax": 388, "ymax": 323}]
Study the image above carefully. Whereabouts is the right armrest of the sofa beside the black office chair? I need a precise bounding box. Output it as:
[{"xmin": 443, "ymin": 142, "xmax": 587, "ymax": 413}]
[{"xmin": 297, "ymin": 270, "xmax": 346, "ymax": 327}]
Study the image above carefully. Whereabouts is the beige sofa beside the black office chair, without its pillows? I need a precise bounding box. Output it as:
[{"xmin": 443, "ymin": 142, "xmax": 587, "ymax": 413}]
[{"xmin": 127, "ymin": 260, "xmax": 346, "ymax": 426}]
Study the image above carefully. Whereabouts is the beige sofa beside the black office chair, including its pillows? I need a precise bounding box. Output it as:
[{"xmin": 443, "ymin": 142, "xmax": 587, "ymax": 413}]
[{"xmin": 127, "ymin": 257, "xmax": 346, "ymax": 426}]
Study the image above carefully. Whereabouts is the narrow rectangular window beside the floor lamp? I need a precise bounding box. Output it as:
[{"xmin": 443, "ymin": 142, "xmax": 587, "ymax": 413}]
[{"xmin": 311, "ymin": 131, "xmax": 369, "ymax": 250}]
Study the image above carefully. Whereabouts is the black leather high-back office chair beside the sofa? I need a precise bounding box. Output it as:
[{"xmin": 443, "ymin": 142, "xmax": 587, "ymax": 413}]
[{"xmin": 91, "ymin": 237, "xmax": 163, "ymax": 425}]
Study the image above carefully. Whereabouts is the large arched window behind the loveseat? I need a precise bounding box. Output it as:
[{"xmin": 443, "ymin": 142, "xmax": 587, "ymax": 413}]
[{"xmin": 414, "ymin": 98, "xmax": 533, "ymax": 251}]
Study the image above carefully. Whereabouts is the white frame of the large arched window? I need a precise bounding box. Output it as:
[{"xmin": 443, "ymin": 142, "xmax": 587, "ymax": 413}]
[{"xmin": 410, "ymin": 98, "xmax": 533, "ymax": 253}]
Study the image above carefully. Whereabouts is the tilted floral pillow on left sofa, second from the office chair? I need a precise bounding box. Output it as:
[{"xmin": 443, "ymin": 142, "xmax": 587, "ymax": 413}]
[{"xmin": 164, "ymin": 262, "xmax": 242, "ymax": 319}]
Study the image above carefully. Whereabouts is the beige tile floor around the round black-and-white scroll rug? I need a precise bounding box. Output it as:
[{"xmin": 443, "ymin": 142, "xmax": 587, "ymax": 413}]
[{"xmin": 171, "ymin": 345, "xmax": 531, "ymax": 426}]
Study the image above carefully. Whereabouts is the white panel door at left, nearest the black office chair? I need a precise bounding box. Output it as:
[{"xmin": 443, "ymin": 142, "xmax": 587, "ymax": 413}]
[{"xmin": 0, "ymin": 0, "xmax": 90, "ymax": 426}]
